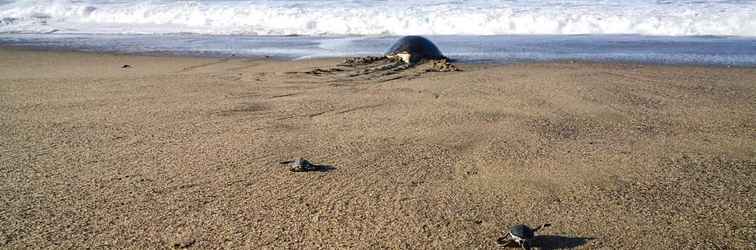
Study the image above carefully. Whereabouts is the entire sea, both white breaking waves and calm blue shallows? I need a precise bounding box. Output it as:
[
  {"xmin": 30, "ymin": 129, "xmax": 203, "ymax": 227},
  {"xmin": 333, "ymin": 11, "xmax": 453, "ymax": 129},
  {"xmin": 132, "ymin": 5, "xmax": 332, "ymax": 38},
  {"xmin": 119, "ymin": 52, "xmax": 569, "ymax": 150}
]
[{"xmin": 0, "ymin": 0, "xmax": 756, "ymax": 66}]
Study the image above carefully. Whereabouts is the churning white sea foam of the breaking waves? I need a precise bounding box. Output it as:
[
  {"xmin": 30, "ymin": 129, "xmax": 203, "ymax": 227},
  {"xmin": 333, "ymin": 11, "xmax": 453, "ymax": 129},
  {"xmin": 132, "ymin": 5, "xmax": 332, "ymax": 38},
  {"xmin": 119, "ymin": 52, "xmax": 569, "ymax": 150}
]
[{"xmin": 0, "ymin": 0, "xmax": 756, "ymax": 36}]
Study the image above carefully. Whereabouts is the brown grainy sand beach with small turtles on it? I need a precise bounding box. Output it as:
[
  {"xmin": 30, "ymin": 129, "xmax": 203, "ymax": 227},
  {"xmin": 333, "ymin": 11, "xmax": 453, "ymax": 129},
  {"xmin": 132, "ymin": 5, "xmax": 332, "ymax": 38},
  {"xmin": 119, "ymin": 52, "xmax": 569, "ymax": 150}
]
[{"xmin": 0, "ymin": 49, "xmax": 756, "ymax": 249}]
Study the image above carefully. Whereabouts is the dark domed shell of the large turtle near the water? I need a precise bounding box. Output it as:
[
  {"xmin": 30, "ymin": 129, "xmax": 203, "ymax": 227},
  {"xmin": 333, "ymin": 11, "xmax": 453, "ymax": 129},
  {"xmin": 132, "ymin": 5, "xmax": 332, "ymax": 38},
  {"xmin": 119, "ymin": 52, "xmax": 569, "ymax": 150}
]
[{"xmin": 384, "ymin": 36, "xmax": 447, "ymax": 63}]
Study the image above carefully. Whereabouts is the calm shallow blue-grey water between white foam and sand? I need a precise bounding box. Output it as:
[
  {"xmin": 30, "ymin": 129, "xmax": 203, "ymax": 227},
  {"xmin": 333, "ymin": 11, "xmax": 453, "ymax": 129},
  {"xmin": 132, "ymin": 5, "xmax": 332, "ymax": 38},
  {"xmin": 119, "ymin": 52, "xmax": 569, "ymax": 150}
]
[{"xmin": 0, "ymin": 34, "xmax": 756, "ymax": 66}]
